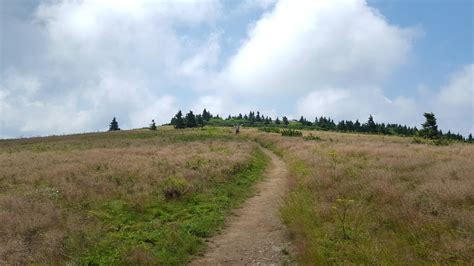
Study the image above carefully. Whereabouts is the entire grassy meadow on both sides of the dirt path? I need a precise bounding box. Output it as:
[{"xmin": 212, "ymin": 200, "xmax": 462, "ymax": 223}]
[{"xmin": 0, "ymin": 126, "xmax": 474, "ymax": 265}]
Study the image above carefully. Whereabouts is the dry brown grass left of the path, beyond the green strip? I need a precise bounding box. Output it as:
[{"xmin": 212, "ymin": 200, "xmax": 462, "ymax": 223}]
[{"xmin": 0, "ymin": 128, "xmax": 254, "ymax": 264}]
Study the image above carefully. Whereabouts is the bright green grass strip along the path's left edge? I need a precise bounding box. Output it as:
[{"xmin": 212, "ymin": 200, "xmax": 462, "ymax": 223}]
[{"xmin": 67, "ymin": 147, "xmax": 269, "ymax": 265}]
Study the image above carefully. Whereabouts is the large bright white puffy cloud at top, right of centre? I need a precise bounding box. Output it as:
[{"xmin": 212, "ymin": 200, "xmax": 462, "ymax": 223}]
[{"xmin": 223, "ymin": 0, "xmax": 416, "ymax": 95}]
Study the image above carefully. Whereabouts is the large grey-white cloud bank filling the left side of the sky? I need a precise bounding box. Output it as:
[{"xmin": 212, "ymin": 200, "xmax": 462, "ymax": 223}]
[{"xmin": 0, "ymin": 0, "xmax": 221, "ymax": 137}]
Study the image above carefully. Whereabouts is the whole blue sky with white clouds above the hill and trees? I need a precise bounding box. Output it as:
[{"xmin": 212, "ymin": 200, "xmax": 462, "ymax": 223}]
[{"xmin": 0, "ymin": 0, "xmax": 474, "ymax": 138}]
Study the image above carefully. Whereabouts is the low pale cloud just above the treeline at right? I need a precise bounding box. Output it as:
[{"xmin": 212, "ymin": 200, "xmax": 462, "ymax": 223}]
[{"xmin": 297, "ymin": 64, "xmax": 474, "ymax": 135}]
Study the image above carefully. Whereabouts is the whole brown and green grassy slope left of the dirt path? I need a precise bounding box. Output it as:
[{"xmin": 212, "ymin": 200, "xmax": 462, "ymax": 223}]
[{"xmin": 0, "ymin": 128, "xmax": 267, "ymax": 264}]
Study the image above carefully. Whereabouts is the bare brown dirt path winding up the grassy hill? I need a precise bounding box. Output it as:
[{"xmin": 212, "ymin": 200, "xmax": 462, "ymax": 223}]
[{"xmin": 191, "ymin": 149, "xmax": 290, "ymax": 265}]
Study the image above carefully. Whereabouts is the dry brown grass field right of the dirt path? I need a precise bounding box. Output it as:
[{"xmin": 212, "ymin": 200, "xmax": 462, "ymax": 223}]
[{"xmin": 250, "ymin": 129, "xmax": 474, "ymax": 264}]
